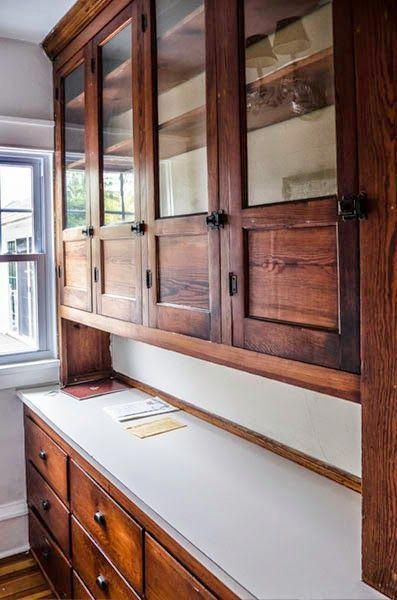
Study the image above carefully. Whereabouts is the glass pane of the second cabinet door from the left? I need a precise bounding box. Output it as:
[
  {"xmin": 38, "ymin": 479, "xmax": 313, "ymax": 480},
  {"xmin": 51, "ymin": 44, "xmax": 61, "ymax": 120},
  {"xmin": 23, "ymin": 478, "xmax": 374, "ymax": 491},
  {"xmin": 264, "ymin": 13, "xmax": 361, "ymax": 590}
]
[{"xmin": 102, "ymin": 25, "xmax": 135, "ymax": 225}]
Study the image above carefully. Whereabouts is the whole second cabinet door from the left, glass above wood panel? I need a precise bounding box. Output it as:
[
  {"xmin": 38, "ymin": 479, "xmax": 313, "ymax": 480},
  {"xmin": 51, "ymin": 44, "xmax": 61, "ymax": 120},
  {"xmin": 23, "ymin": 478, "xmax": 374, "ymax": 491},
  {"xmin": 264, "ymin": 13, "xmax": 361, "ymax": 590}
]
[{"xmin": 93, "ymin": 2, "xmax": 145, "ymax": 322}]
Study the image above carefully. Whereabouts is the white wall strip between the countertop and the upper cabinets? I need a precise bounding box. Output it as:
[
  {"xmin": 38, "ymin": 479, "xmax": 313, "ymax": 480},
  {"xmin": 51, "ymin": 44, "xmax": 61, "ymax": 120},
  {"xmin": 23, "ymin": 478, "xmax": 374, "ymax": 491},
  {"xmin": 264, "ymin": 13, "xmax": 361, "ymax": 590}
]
[{"xmin": 112, "ymin": 336, "xmax": 361, "ymax": 476}]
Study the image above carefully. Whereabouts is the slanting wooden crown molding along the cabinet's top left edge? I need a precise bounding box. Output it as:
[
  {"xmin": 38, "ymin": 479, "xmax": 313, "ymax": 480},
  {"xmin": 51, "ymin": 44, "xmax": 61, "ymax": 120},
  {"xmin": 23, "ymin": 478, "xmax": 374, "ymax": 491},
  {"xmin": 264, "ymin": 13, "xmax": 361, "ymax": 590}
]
[{"xmin": 42, "ymin": 0, "xmax": 114, "ymax": 60}]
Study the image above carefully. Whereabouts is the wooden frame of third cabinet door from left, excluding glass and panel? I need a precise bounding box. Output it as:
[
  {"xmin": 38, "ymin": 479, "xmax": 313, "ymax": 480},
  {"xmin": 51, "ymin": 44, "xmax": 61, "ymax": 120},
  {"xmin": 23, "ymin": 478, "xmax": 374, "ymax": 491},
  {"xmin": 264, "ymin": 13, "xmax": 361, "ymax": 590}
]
[{"xmin": 142, "ymin": 0, "xmax": 221, "ymax": 342}]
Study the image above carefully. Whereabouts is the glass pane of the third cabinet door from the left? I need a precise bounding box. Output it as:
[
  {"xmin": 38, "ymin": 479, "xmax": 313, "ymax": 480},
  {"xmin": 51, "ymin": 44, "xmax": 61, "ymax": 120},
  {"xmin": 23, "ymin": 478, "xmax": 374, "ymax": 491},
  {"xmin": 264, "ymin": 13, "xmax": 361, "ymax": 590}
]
[{"xmin": 156, "ymin": 0, "xmax": 208, "ymax": 217}]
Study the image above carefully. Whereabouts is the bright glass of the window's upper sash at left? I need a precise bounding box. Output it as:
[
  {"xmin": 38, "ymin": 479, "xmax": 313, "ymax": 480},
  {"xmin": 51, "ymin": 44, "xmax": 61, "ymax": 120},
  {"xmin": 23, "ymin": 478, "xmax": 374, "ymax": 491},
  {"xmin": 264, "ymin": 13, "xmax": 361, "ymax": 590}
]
[{"xmin": 0, "ymin": 165, "xmax": 34, "ymax": 254}]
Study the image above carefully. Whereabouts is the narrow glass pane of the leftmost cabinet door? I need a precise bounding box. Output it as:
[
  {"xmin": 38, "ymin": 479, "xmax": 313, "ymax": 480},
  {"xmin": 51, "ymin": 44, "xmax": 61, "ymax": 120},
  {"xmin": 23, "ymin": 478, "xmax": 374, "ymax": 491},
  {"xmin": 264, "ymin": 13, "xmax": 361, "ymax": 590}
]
[{"xmin": 64, "ymin": 64, "xmax": 87, "ymax": 228}]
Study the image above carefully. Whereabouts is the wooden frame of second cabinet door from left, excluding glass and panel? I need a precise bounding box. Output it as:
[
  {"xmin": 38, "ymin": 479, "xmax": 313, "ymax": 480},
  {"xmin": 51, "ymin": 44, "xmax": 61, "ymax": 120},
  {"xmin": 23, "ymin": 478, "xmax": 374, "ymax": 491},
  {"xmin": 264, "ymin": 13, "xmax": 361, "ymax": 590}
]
[{"xmin": 88, "ymin": 0, "xmax": 147, "ymax": 323}]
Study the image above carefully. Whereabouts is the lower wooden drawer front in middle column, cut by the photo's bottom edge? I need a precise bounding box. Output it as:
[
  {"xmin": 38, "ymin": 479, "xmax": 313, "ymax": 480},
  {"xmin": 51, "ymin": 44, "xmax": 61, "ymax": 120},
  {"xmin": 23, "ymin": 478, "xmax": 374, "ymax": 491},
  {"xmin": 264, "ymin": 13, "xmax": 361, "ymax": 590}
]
[{"xmin": 72, "ymin": 517, "xmax": 139, "ymax": 600}]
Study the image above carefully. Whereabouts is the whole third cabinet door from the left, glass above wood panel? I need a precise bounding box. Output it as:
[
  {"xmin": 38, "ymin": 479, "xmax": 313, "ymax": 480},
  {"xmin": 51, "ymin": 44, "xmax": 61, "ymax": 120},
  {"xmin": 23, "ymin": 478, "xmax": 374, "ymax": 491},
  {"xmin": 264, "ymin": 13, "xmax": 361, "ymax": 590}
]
[{"xmin": 147, "ymin": 0, "xmax": 219, "ymax": 339}]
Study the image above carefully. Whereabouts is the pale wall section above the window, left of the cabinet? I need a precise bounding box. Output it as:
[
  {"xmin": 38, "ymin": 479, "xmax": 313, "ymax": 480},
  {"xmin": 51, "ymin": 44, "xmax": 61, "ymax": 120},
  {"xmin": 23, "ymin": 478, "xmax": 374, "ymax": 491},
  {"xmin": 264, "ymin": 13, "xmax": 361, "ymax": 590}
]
[{"xmin": 0, "ymin": 38, "xmax": 53, "ymax": 150}]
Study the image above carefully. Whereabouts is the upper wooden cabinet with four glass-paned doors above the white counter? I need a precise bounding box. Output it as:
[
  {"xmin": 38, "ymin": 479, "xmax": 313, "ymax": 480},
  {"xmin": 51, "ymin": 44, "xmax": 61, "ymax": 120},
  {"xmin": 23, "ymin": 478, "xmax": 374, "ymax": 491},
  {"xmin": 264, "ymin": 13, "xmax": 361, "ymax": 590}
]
[{"xmin": 56, "ymin": 0, "xmax": 360, "ymax": 384}]
